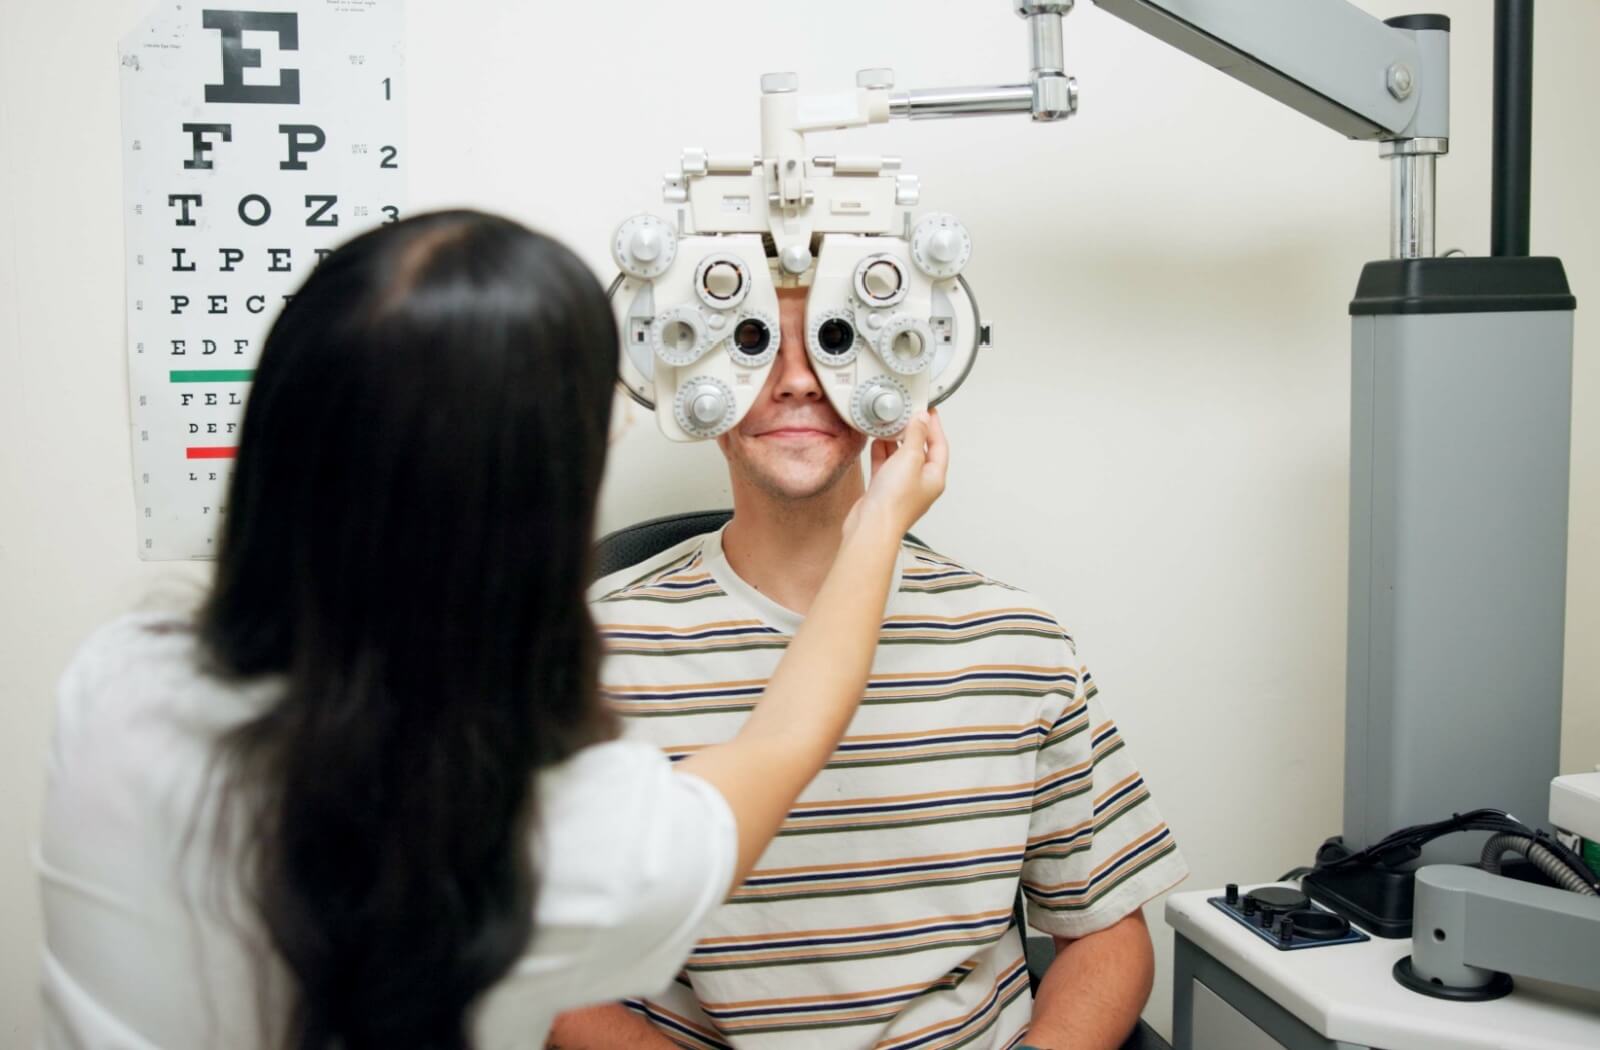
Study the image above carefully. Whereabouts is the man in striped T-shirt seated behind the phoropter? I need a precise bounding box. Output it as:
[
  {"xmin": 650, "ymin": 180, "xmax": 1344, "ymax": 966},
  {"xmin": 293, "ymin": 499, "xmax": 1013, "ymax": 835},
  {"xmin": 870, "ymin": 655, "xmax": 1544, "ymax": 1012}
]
[{"xmin": 550, "ymin": 290, "xmax": 1187, "ymax": 1050}]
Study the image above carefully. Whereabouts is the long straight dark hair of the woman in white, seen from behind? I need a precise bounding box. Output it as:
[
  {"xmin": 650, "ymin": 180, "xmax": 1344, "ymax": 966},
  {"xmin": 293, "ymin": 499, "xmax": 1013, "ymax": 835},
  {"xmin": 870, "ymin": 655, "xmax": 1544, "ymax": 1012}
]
[{"xmin": 200, "ymin": 211, "xmax": 616, "ymax": 1050}]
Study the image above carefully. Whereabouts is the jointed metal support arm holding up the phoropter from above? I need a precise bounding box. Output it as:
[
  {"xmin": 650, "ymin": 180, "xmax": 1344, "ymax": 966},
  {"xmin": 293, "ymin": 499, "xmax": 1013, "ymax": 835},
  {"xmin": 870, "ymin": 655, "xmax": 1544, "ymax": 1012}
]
[{"xmin": 742, "ymin": 0, "xmax": 1450, "ymax": 266}]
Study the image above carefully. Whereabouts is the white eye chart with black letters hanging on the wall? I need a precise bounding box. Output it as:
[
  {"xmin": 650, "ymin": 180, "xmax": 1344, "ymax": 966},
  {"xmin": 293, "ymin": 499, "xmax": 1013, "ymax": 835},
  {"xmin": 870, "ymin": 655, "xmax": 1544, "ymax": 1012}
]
[{"xmin": 120, "ymin": 0, "xmax": 408, "ymax": 560}]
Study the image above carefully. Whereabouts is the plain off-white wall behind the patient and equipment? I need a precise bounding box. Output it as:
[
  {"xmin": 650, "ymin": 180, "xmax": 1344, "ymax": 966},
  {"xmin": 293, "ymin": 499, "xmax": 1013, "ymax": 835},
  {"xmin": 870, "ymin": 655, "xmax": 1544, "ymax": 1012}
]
[{"xmin": 0, "ymin": 0, "xmax": 1600, "ymax": 1047}]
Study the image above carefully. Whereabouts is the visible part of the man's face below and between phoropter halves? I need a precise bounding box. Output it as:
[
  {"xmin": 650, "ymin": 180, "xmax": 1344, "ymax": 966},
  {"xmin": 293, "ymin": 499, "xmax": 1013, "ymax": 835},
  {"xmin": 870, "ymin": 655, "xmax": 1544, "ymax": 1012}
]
[{"xmin": 717, "ymin": 288, "xmax": 867, "ymax": 501}]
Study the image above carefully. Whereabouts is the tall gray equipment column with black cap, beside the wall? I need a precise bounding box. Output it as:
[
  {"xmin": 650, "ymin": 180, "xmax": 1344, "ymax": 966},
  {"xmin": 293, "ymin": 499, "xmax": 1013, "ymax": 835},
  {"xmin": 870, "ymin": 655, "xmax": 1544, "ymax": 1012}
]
[{"xmin": 1344, "ymin": 258, "xmax": 1576, "ymax": 861}]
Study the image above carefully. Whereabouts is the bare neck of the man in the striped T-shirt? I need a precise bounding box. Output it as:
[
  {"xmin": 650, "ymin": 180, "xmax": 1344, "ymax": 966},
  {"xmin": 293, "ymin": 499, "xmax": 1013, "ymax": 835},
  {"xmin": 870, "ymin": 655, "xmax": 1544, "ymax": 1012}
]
[{"xmin": 722, "ymin": 472, "xmax": 866, "ymax": 616}]
